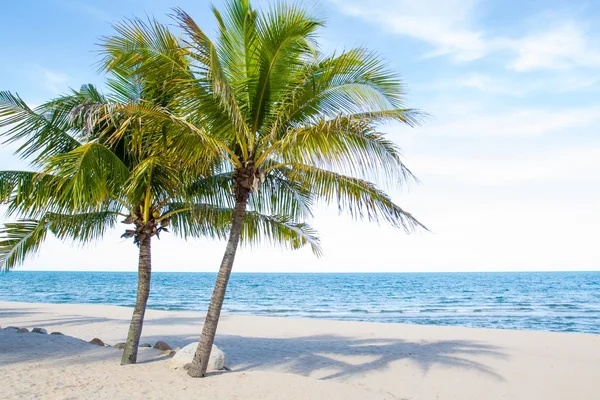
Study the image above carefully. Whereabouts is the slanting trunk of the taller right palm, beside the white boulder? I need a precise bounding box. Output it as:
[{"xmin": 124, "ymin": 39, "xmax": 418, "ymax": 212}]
[{"xmin": 188, "ymin": 188, "xmax": 250, "ymax": 378}]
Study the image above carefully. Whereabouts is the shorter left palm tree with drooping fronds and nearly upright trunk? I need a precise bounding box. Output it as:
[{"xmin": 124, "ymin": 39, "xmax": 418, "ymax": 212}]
[{"xmin": 0, "ymin": 69, "xmax": 319, "ymax": 364}]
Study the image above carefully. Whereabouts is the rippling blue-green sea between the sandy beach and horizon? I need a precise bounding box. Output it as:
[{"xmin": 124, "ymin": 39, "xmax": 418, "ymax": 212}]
[{"xmin": 0, "ymin": 271, "xmax": 600, "ymax": 334}]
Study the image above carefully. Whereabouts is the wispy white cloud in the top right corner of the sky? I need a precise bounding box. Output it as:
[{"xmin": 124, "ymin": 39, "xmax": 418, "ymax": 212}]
[{"xmin": 330, "ymin": 0, "xmax": 600, "ymax": 72}]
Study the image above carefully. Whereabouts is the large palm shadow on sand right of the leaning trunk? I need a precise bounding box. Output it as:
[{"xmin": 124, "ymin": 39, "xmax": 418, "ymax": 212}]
[{"xmin": 216, "ymin": 335, "xmax": 508, "ymax": 381}]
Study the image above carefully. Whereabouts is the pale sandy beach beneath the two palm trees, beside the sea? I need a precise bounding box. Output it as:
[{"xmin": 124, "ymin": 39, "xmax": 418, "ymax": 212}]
[{"xmin": 0, "ymin": 302, "xmax": 600, "ymax": 400}]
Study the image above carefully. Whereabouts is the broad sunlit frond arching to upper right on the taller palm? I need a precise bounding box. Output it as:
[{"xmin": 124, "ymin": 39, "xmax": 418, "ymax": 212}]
[{"xmin": 264, "ymin": 48, "xmax": 424, "ymax": 138}]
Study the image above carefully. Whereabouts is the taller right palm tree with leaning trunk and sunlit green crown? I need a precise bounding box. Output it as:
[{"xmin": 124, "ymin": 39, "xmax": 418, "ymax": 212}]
[{"xmin": 98, "ymin": 0, "xmax": 423, "ymax": 377}]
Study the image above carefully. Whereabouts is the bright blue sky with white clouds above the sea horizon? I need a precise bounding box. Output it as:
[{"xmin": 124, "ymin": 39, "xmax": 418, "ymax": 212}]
[{"xmin": 0, "ymin": 0, "xmax": 600, "ymax": 272}]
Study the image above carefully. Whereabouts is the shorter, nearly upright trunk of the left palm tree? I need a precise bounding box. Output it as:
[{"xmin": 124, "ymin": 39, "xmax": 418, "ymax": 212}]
[{"xmin": 121, "ymin": 235, "xmax": 152, "ymax": 365}]
